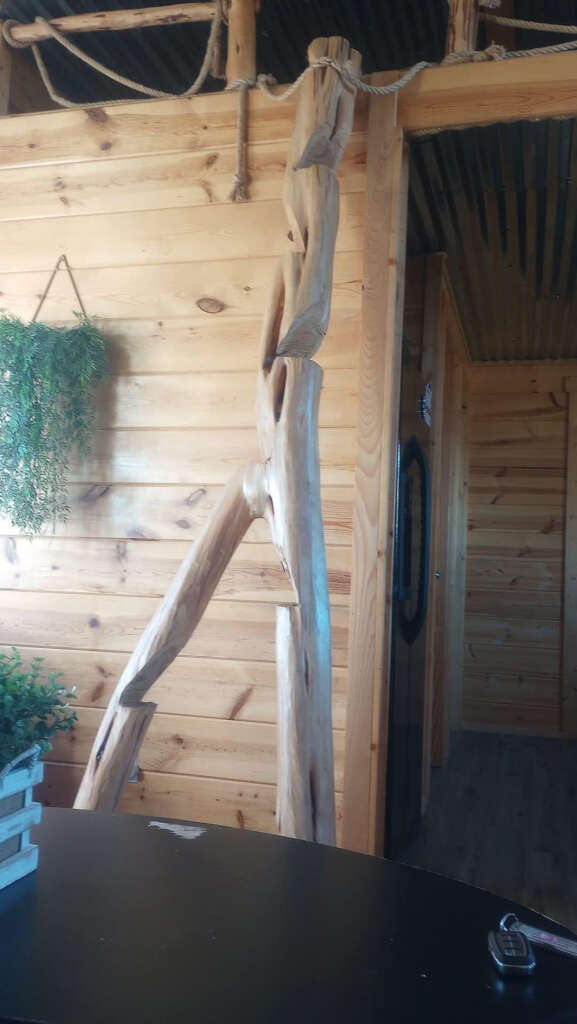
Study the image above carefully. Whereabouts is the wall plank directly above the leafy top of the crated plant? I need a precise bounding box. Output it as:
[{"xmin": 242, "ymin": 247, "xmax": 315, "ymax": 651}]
[{"xmin": 0, "ymin": 591, "xmax": 348, "ymax": 668}]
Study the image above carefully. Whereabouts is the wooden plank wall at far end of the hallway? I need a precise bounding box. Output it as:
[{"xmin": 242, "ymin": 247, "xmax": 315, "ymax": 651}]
[{"xmin": 463, "ymin": 364, "xmax": 568, "ymax": 733}]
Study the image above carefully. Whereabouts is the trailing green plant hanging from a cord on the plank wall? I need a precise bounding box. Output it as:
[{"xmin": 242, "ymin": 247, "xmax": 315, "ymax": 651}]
[{"xmin": 0, "ymin": 261, "xmax": 108, "ymax": 534}]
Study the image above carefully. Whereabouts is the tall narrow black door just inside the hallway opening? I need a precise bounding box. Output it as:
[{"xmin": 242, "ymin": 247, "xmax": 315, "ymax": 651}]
[{"xmin": 385, "ymin": 342, "xmax": 430, "ymax": 857}]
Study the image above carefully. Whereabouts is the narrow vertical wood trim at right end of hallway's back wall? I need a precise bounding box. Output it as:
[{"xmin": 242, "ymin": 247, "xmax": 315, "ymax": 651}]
[{"xmin": 561, "ymin": 377, "xmax": 577, "ymax": 738}]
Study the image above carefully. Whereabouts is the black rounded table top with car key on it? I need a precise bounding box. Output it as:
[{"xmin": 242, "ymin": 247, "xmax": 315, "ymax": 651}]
[{"xmin": 0, "ymin": 809, "xmax": 577, "ymax": 1024}]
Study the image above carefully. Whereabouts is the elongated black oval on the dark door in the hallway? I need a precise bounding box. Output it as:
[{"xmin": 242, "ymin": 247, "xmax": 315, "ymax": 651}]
[{"xmin": 398, "ymin": 435, "xmax": 430, "ymax": 644}]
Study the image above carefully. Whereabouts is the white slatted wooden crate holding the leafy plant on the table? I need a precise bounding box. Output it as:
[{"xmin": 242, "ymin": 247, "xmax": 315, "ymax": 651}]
[{"xmin": 0, "ymin": 748, "xmax": 44, "ymax": 889}]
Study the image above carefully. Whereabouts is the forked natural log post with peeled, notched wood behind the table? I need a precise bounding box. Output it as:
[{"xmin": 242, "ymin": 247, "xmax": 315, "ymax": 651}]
[{"xmin": 75, "ymin": 37, "xmax": 361, "ymax": 844}]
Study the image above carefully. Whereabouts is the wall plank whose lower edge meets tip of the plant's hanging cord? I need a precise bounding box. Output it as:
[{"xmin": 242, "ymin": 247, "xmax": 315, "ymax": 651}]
[{"xmin": 0, "ymin": 193, "xmax": 365, "ymax": 274}]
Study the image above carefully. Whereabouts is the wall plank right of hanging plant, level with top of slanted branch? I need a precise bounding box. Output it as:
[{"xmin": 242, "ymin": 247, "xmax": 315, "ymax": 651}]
[{"xmin": 70, "ymin": 427, "xmax": 357, "ymax": 486}]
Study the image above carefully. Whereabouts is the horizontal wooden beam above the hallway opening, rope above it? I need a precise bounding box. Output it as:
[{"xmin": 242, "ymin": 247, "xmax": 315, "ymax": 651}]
[{"xmin": 372, "ymin": 51, "xmax": 577, "ymax": 132}]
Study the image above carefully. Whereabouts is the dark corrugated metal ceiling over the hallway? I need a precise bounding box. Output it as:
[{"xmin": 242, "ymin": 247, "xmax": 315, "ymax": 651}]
[{"xmin": 409, "ymin": 120, "xmax": 577, "ymax": 359}]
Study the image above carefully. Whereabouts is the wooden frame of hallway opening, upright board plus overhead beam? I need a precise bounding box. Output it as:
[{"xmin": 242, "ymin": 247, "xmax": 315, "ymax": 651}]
[{"xmin": 343, "ymin": 41, "xmax": 577, "ymax": 853}]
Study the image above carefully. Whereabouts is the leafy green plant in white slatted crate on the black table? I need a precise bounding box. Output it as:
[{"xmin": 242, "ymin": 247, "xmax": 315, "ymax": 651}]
[{"xmin": 0, "ymin": 650, "xmax": 77, "ymax": 889}]
